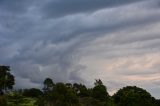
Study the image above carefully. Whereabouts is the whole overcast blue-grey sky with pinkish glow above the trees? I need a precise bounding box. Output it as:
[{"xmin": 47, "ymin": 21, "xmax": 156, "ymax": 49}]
[{"xmin": 0, "ymin": 0, "xmax": 160, "ymax": 98}]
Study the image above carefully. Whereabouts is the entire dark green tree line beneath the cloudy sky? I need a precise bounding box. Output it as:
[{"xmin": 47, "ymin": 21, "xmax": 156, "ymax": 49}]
[{"xmin": 0, "ymin": 66, "xmax": 160, "ymax": 106}]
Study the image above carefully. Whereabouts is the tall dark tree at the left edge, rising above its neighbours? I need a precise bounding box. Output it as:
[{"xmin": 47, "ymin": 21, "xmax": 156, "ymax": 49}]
[{"xmin": 0, "ymin": 65, "xmax": 15, "ymax": 94}]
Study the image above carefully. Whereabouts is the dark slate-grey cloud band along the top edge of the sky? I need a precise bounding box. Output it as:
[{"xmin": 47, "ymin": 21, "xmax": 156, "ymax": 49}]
[{"xmin": 43, "ymin": 0, "xmax": 146, "ymax": 18}]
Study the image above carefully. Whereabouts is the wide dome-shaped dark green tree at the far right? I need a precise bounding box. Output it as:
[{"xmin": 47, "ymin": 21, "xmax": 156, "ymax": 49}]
[{"xmin": 113, "ymin": 86, "xmax": 153, "ymax": 106}]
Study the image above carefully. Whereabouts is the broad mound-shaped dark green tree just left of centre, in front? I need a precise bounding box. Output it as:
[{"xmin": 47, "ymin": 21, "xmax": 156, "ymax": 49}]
[{"xmin": 37, "ymin": 83, "xmax": 79, "ymax": 106}]
